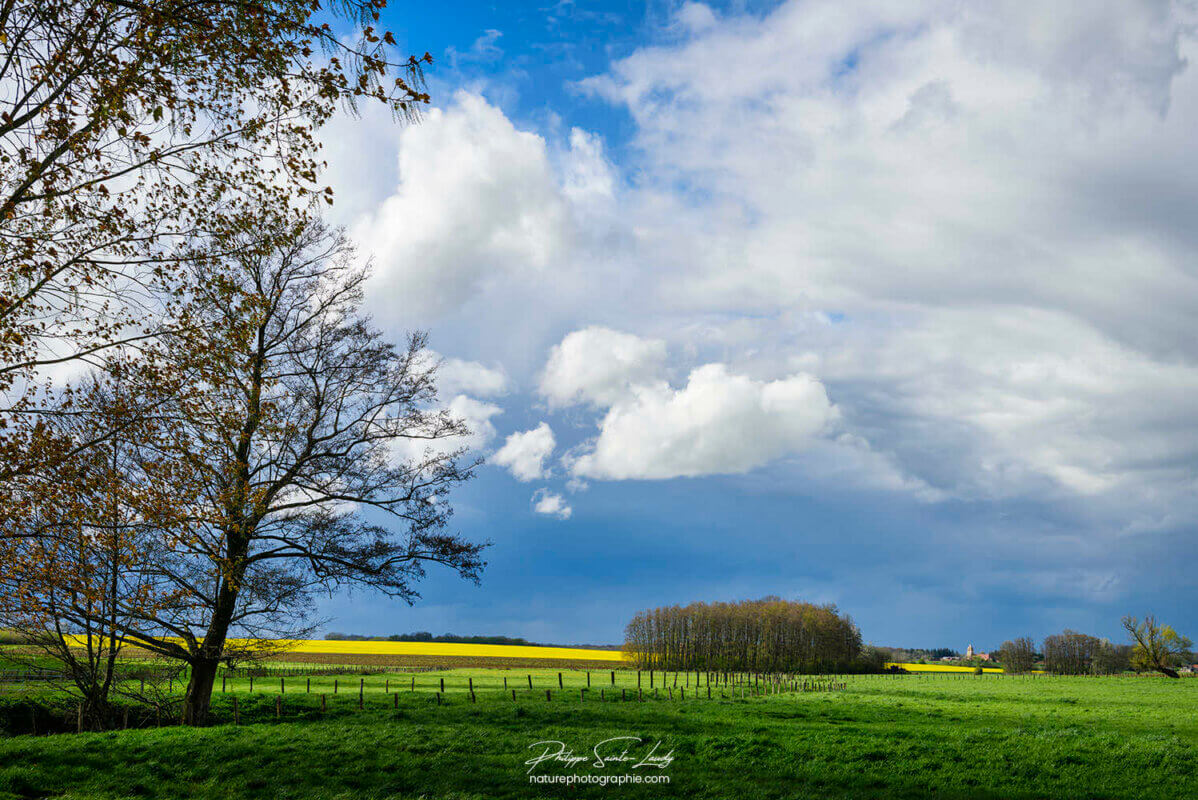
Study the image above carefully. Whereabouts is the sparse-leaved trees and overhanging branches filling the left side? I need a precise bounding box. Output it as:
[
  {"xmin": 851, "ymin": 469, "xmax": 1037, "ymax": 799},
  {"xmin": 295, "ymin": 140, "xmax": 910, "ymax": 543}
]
[{"xmin": 0, "ymin": 0, "xmax": 483, "ymax": 727}]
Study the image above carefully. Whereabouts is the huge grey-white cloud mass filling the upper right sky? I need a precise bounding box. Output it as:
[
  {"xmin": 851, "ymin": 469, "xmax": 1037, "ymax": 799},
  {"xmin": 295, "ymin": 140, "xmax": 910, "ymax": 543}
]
[{"xmin": 586, "ymin": 0, "xmax": 1198, "ymax": 508}]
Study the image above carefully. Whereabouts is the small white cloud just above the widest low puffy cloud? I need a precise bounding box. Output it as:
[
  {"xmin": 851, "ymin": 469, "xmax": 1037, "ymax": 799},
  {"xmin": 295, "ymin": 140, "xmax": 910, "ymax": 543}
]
[{"xmin": 540, "ymin": 327, "xmax": 666, "ymax": 406}]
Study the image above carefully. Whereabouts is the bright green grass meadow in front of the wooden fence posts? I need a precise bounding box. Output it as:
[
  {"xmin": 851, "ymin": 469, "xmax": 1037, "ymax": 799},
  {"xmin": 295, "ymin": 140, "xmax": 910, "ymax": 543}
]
[{"xmin": 0, "ymin": 672, "xmax": 1198, "ymax": 800}]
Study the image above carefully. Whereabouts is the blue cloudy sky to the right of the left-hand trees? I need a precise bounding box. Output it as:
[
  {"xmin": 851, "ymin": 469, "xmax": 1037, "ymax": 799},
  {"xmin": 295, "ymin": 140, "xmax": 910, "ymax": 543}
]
[{"xmin": 306, "ymin": 0, "xmax": 1198, "ymax": 650}]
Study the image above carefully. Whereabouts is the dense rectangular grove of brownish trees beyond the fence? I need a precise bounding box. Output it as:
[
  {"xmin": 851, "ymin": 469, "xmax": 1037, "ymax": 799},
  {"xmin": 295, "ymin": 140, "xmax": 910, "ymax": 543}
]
[{"xmin": 624, "ymin": 596, "xmax": 867, "ymax": 673}]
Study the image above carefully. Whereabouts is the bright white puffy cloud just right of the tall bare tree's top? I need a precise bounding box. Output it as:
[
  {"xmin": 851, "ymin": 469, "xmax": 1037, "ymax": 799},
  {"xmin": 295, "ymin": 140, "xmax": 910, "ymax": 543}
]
[{"xmin": 352, "ymin": 92, "xmax": 571, "ymax": 320}]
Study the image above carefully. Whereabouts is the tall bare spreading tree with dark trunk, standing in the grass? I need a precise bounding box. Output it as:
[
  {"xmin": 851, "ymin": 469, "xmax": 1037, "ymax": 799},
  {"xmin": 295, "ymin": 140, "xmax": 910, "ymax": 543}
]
[{"xmin": 127, "ymin": 218, "xmax": 483, "ymax": 723}]
